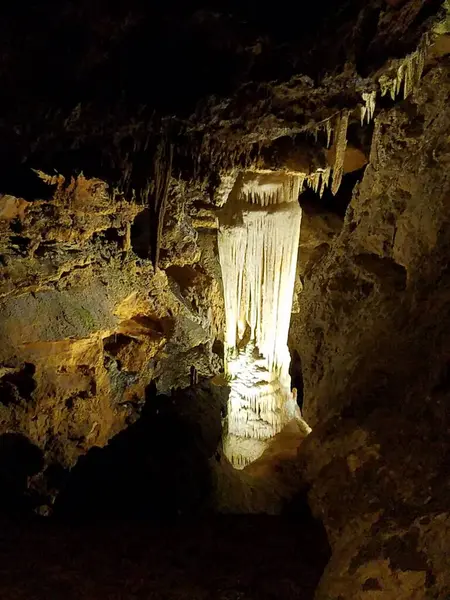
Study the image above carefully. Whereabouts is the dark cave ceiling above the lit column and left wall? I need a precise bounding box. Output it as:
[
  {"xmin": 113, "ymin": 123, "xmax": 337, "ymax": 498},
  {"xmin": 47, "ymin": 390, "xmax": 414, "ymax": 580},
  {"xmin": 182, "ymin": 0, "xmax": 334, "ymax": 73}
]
[{"xmin": 0, "ymin": 0, "xmax": 442, "ymax": 202}]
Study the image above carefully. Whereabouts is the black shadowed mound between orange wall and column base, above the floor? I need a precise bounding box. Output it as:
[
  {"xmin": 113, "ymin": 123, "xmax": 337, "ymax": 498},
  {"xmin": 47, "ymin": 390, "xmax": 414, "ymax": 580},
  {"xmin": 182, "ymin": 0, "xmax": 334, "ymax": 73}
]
[{"xmin": 54, "ymin": 382, "xmax": 226, "ymax": 520}]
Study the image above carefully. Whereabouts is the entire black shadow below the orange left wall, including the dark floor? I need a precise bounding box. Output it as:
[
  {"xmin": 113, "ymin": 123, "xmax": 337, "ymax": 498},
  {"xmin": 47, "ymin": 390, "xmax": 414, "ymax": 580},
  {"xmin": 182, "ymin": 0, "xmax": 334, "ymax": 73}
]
[{"xmin": 0, "ymin": 381, "xmax": 330, "ymax": 600}]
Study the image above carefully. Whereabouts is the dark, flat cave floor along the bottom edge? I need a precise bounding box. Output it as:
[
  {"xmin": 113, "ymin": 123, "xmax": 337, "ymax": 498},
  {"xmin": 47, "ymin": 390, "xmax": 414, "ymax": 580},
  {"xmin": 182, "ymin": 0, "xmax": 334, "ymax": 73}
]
[{"xmin": 0, "ymin": 516, "xmax": 328, "ymax": 600}]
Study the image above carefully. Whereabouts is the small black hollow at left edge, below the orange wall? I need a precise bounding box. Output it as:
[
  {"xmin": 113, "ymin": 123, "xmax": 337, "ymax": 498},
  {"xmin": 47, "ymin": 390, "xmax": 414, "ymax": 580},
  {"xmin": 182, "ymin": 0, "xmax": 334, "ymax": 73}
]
[{"xmin": 0, "ymin": 433, "xmax": 44, "ymax": 516}]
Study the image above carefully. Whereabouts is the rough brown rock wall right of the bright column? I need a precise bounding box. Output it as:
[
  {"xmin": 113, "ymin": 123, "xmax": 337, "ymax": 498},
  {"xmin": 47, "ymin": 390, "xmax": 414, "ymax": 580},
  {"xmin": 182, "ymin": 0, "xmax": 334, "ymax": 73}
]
[{"xmin": 297, "ymin": 59, "xmax": 450, "ymax": 600}]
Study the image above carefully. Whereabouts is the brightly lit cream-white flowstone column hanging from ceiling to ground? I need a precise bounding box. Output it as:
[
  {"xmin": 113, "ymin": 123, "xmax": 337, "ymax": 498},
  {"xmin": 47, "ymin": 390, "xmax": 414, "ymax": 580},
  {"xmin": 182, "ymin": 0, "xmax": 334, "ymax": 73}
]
[{"xmin": 219, "ymin": 174, "xmax": 301, "ymax": 468}]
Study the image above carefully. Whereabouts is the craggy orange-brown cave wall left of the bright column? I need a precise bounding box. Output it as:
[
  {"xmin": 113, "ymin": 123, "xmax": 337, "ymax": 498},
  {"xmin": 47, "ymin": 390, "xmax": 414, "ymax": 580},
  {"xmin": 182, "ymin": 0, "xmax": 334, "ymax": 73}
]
[{"xmin": 0, "ymin": 173, "xmax": 223, "ymax": 478}]
